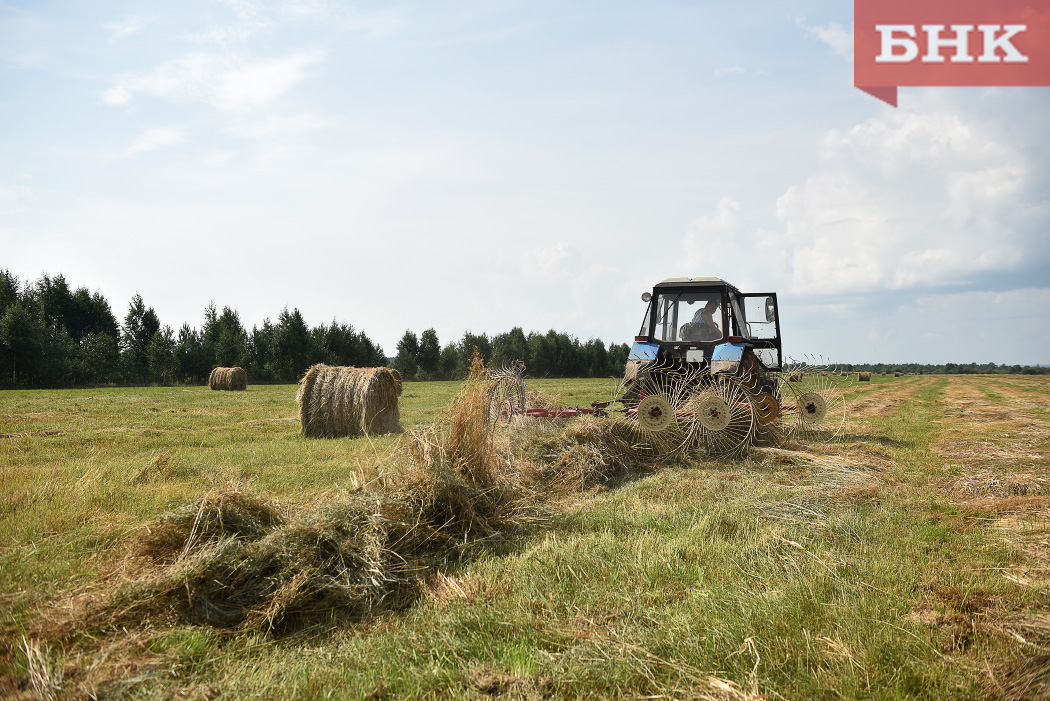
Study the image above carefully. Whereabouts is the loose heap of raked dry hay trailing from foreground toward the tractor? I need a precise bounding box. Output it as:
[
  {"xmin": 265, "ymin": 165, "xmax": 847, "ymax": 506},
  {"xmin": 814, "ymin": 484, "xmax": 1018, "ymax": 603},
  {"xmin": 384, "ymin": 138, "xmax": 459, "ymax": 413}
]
[{"xmin": 63, "ymin": 362, "xmax": 663, "ymax": 634}]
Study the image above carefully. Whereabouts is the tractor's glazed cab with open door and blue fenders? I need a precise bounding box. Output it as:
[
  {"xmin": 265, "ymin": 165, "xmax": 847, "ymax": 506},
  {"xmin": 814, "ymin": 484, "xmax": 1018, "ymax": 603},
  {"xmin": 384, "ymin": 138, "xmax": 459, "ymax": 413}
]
[{"xmin": 628, "ymin": 277, "xmax": 781, "ymax": 376}]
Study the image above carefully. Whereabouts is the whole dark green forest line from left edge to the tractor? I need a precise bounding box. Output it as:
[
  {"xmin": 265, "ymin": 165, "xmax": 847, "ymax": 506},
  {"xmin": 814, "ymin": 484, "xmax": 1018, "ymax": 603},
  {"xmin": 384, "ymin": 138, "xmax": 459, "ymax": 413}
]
[{"xmin": 0, "ymin": 270, "xmax": 630, "ymax": 387}]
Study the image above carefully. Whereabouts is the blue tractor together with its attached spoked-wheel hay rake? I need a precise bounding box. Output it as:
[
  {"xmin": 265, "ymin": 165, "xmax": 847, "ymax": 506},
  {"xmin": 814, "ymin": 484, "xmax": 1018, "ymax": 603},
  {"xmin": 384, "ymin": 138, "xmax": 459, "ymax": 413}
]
[{"xmin": 489, "ymin": 278, "xmax": 851, "ymax": 456}]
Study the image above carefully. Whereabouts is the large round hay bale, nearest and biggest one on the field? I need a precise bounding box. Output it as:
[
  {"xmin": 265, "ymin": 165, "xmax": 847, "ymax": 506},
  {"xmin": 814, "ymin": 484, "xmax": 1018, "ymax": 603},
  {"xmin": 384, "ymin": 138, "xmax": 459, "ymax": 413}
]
[{"xmin": 295, "ymin": 364, "xmax": 401, "ymax": 438}]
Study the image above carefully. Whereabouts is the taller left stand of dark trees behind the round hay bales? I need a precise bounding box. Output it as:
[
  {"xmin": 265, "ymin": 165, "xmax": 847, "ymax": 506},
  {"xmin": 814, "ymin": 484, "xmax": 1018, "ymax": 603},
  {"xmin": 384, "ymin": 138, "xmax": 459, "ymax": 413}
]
[{"xmin": 0, "ymin": 270, "xmax": 386, "ymax": 387}]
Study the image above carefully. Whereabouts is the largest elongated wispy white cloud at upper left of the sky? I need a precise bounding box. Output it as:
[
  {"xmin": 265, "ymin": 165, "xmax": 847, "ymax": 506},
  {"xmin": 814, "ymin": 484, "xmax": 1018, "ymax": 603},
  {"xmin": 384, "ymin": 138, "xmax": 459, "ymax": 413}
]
[{"xmin": 104, "ymin": 51, "xmax": 324, "ymax": 112}]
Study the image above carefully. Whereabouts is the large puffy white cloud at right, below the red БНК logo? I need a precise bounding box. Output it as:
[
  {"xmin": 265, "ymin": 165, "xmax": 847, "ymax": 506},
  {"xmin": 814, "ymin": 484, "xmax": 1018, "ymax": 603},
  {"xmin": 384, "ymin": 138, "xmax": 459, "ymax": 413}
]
[{"xmin": 776, "ymin": 111, "xmax": 1048, "ymax": 295}]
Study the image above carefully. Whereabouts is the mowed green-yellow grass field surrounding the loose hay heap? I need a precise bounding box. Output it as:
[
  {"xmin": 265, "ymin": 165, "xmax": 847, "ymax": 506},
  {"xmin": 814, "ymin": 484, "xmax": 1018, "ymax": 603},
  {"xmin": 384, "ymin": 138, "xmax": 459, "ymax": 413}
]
[{"xmin": 0, "ymin": 376, "xmax": 1050, "ymax": 699}]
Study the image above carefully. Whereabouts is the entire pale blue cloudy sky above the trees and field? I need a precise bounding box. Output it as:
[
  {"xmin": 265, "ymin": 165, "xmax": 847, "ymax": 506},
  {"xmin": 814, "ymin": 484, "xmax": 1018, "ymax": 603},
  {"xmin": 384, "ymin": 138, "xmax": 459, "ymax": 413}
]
[{"xmin": 0, "ymin": 0, "xmax": 1050, "ymax": 364}]
